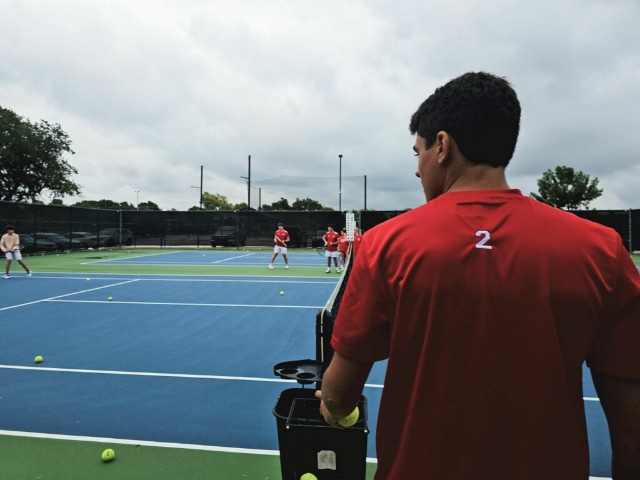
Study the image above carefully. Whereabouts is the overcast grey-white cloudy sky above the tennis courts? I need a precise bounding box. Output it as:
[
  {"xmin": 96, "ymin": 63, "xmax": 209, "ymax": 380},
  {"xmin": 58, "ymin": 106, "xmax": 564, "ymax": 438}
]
[{"xmin": 0, "ymin": 0, "xmax": 640, "ymax": 210}]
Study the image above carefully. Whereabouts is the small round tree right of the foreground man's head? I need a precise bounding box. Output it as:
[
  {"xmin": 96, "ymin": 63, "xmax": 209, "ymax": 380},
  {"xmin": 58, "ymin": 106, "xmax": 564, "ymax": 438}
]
[{"xmin": 531, "ymin": 165, "xmax": 602, "ymax": 210}]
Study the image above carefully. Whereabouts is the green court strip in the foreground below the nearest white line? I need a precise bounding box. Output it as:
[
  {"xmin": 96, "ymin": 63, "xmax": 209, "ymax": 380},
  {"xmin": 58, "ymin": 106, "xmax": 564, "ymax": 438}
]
[{"xmin": 0, "ymin": 435, "xmax": 375, "ymax": 480}]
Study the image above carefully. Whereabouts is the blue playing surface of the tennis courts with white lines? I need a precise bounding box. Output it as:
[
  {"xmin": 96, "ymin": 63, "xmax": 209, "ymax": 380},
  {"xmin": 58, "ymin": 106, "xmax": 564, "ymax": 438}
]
[{"xmin": 0, "ymin": 251, "xmax": 610, "ymax": 477}]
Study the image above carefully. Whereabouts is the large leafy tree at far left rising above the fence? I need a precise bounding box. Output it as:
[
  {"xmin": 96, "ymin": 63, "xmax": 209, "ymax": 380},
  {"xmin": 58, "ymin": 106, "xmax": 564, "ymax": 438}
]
[{"xmin": 0, "ymin": 107, "xmax": 80, "ymax": 202}]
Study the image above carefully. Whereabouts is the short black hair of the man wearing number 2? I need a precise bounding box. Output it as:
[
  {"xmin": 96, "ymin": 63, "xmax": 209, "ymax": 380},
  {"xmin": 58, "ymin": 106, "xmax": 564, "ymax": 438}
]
[{"xmin": 409, "ymin": 72, "xmax": 520, "ymax": 167}]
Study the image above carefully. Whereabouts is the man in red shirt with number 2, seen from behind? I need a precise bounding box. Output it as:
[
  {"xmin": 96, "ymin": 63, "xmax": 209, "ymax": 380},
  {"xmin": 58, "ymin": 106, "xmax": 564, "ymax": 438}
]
[{"xmin": 316, "ymin": 69, "xmax": 640, "ymax": 480}]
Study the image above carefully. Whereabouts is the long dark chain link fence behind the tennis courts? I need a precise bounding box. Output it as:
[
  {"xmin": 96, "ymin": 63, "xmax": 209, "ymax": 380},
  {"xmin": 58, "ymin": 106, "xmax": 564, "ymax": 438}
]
[{"xmin": 0, "ymin": 202, "xmax": 640, "ymax": 253}]
